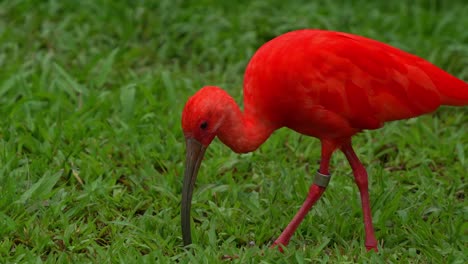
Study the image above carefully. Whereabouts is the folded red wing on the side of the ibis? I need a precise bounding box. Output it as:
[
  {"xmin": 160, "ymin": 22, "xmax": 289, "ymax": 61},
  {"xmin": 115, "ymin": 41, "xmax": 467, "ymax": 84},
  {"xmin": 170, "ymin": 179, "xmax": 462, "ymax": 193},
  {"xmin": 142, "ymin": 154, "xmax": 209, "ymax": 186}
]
[{"xmin": 308, "ymin": 33, "xmax": 451, "ymax": 129}]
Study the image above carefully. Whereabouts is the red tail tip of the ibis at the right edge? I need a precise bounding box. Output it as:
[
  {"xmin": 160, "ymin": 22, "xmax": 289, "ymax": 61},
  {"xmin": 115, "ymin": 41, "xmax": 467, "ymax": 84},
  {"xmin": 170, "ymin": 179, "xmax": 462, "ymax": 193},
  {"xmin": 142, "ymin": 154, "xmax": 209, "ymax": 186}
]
[{"xmin": 438, "ymin": 75, "xmax": 468, "ymax": 106}]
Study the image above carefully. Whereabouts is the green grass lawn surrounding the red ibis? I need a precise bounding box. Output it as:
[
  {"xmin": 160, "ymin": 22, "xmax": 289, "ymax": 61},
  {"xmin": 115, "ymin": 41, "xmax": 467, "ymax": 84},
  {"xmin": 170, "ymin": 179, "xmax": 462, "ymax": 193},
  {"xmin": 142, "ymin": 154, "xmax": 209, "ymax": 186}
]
[{"xmin": 0, "ymin": 0, "xmax": 468, "ymax": 263}]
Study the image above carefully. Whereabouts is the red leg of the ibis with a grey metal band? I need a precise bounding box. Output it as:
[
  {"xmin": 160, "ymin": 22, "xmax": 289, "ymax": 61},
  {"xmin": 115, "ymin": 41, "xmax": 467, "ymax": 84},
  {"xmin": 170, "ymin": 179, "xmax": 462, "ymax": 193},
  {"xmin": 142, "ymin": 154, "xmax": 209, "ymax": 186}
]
[{"xmin": 272, "ymin": 141, "xmax": 336, "ymax": 252}]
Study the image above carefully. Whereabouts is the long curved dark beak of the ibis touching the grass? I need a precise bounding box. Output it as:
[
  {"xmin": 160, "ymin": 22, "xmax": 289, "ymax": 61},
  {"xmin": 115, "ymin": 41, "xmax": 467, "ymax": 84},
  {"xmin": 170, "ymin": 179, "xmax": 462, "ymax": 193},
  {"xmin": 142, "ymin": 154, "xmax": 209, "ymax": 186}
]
[{"xmin": 180, "ymin": 138, "xmax": 206, "ymax": 246}]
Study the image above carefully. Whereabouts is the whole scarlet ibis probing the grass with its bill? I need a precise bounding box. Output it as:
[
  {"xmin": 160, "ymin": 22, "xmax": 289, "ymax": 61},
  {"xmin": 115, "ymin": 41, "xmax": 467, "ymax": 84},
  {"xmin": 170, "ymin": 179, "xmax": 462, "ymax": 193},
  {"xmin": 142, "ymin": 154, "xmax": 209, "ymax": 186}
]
[{"xmin": 181, "ymin": 30, "xmax": 468, "ymax": 251}]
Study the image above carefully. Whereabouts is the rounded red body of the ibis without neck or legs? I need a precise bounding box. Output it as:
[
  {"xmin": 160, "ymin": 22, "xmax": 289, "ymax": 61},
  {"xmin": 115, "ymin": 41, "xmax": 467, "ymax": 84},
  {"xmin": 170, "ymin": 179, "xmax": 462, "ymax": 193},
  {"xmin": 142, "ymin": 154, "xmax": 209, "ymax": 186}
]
[{"xmin": 244, "ymin": 30, "xmax": 468, "ymax": 136}]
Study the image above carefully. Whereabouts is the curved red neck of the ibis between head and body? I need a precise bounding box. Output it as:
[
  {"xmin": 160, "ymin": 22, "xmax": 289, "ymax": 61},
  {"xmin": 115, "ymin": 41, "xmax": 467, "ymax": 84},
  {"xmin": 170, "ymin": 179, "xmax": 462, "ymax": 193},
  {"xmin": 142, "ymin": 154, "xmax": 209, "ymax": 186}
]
[{"xmin": 218, "ymin": 98, "xmax": 276, "ymax": 153}]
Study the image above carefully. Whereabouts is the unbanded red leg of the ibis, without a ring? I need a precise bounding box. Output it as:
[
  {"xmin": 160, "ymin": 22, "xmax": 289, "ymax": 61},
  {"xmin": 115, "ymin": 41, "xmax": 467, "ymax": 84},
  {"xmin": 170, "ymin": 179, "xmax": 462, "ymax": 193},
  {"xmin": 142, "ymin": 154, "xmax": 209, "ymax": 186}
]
[{"xmin": 341, "ymin": 141, "xmax": 378, "ymax": 251}]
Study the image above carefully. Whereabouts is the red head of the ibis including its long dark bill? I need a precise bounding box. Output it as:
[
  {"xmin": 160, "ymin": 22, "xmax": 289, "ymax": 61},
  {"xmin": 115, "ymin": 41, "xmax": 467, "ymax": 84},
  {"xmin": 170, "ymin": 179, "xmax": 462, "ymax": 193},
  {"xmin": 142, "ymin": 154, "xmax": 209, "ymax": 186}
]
[{"xmin": 181, "ymin": 86, "xmax": 230, "ymax": 245}]
